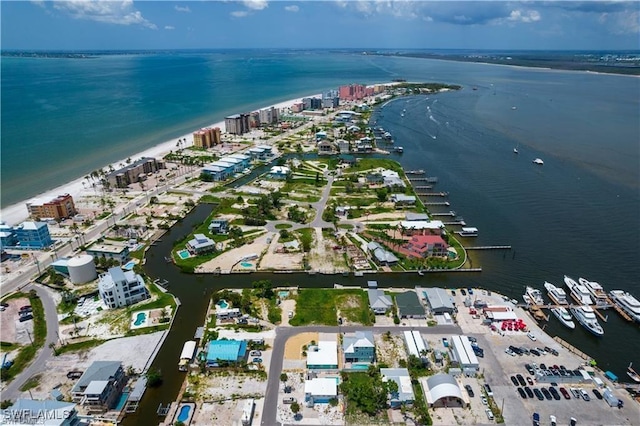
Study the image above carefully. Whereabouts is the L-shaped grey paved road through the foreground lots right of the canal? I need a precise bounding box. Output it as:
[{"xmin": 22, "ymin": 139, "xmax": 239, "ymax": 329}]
[{"xmin": 260, "ymin": 325, "xmax": 463, "ymax": 426}]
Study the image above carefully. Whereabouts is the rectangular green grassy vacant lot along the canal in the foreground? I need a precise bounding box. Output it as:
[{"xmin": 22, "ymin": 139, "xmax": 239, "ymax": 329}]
[{"xmin": 289, "ymin": 288, "xmax": 372, "ymax": 325}]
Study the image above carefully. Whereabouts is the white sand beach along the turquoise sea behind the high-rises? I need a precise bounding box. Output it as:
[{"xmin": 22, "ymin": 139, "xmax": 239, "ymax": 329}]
[{"xmin": 0, "ymin": 93, "xmax": 321, "ymax": 225}]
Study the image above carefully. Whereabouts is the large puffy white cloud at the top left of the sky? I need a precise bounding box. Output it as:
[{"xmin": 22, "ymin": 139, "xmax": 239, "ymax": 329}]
[{"xmin": 53, "ymin": 0, "xmax": 158, "ymax": 30}]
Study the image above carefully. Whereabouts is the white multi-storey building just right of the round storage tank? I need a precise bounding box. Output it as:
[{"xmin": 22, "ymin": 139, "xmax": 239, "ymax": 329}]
[{"xmin": 98, "ymin": 267, "xmax": 149, "ymax": 309}]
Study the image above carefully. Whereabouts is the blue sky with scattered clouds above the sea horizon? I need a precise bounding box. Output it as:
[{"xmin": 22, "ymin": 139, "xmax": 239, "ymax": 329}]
[{"xmin": 0, "ymin": 0, "xmax": 640, "ymax": 50}]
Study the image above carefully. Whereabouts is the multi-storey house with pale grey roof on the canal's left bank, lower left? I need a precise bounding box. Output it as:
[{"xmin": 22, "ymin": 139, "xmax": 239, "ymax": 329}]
[{"xmin": 71, "ymin": 361, "xmax": 127, "ymax": 410}]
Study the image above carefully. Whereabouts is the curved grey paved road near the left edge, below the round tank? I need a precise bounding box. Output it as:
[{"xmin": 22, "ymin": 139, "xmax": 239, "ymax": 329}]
[{"xmin": 2, "ymin": 284, "xmax": 58, "ymax": 401}]
